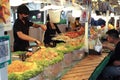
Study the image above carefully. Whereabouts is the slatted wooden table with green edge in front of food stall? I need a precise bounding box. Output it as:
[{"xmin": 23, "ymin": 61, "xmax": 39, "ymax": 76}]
[{"xmin": 61, "ymin": 53, "xmax": 109, "ymax": 80}]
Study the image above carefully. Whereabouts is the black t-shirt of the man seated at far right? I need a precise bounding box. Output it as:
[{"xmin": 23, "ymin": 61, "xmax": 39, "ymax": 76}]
[{"xmin": 109, "ymin": 42, "xmax": 120, "ymax": 65}]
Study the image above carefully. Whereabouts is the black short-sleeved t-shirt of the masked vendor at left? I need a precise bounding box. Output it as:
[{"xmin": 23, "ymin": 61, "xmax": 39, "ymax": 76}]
[{"xmin": 13, "ymin": 19, "xmax": 33, "ymax": 51}]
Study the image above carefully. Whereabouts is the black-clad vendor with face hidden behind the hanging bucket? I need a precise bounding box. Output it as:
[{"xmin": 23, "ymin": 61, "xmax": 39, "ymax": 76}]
[{"xmin": 44, "ymin": 14, "xmax": 61, "ymax": 47}]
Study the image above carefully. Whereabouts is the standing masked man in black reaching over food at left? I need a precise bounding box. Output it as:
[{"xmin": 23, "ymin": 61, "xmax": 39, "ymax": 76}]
[{"xmin": 13, "ymin": 4, "xmax": 46, "ymax": 51}]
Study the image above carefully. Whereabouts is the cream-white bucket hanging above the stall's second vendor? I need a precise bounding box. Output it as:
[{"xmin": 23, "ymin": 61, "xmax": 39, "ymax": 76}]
[{"xmin": 48, "ymin": 9, "xmax": 61, "ymax": 23}]
